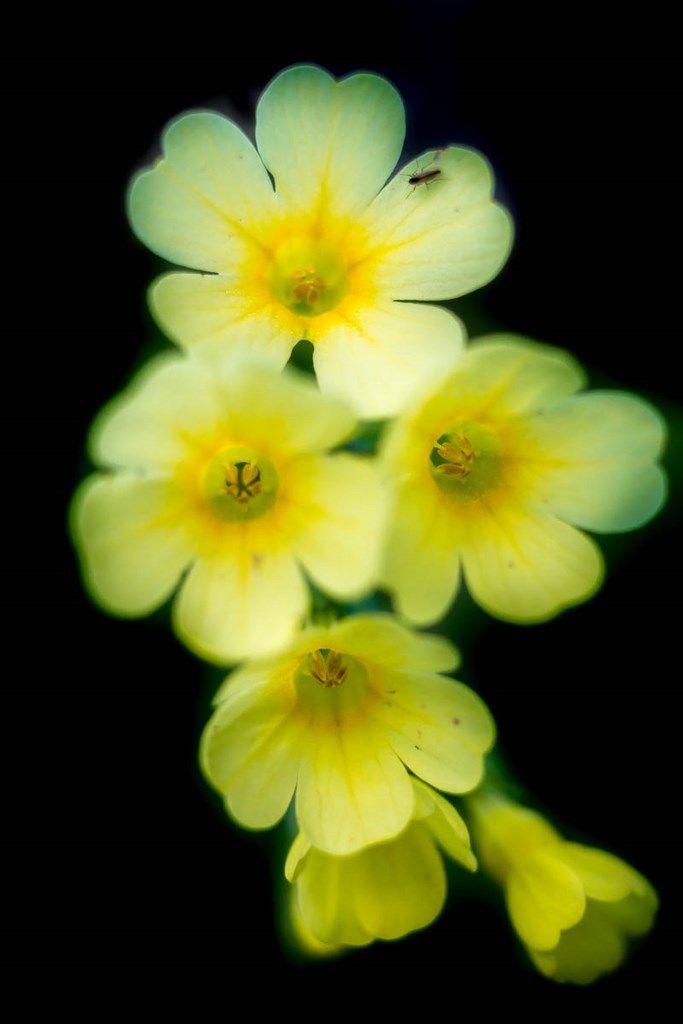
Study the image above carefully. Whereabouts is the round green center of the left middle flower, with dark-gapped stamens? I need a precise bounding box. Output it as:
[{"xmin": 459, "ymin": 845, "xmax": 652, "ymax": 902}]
[{"xmin": 202, "ymin": 447, "xmax": 279, "ymax": 522}]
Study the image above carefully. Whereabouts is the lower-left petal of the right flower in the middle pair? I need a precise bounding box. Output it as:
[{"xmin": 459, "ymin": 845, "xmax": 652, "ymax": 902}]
[{"xmin": 383, "ymin": 481, "xmax": 460, "ymax": 626}]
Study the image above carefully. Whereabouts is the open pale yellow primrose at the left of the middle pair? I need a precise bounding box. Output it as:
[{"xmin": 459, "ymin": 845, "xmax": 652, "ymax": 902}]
[{"xmin": 72, "ymin": 354, "xmax": 386, "ymax": 660}]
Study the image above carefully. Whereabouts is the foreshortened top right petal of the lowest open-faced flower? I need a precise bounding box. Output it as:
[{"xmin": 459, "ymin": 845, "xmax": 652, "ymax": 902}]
[{"xmin": 327, "ymin": 614, "xmax": 460, "ymax": 672}]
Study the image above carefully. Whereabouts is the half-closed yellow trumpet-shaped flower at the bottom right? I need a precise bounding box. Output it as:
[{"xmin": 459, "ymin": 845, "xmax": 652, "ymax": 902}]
[{"xmin": 469, "ymin": 792, "xmax": 657, "ymax": 985}]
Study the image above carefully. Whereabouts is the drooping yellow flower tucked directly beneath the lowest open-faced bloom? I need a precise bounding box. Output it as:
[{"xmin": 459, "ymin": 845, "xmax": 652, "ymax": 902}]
[{"xmin": 285, "ymin": 779, "xmax": 476, "ymax": 951}]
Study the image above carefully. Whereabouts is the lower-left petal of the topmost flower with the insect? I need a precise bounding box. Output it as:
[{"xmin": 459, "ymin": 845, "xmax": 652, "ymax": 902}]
[{"xmin": 150, "ymin": 273, "xmax": 298, "ymax": 370}]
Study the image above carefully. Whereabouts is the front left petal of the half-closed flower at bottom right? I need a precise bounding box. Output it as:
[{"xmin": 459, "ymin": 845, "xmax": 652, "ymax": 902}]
[{"xmin": 506, "ymin": 848, "xmax": 586, "ymax": 950}]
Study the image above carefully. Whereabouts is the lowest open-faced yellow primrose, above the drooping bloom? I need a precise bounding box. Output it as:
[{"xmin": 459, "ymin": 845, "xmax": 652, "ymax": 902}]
[{"xmin": 201, "ymin": 615, "xmax": 494, "ymax": 856}]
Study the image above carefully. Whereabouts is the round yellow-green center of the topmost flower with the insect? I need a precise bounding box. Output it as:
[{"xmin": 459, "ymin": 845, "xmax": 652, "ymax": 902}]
[{"xmin": 270, "ymin": 236, "xmax": 348, "ymax": 316}]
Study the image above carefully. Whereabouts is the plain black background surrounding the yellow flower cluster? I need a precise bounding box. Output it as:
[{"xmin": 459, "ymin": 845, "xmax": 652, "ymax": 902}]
[{"xmin": 3, "ymin": 0, "xmax": 683, "ymax": 1013}]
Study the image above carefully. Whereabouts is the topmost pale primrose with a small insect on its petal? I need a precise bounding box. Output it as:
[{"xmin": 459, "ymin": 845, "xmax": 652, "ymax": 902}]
[{"xmin": 129, "ymin": 66, "xmax": 511, "ymax": 417}]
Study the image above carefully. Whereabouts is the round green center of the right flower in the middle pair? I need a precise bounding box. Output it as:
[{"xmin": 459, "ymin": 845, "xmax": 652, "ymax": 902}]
[{"xmin": 429, "ymin": 422, "xmax": 501, "ymax": 502}]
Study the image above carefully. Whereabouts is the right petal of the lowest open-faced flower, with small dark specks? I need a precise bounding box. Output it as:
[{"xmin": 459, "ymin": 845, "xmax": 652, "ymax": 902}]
[{"xmin": 370, "ymin": 671, "xmax": 496, "ymax": 793}]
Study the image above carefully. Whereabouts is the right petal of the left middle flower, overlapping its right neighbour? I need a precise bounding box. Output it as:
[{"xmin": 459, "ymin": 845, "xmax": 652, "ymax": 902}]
[{"xmin": 293, "ymin": 455, "xmax": 386, "ymax": 598}]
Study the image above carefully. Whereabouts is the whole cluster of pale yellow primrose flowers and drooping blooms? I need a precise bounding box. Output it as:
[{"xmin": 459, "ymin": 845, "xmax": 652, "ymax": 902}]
[{"xmin": 71, "ymin": 67, "xmax": 665, "ymax": 982}]
